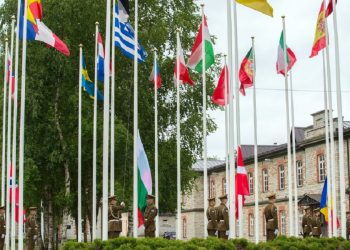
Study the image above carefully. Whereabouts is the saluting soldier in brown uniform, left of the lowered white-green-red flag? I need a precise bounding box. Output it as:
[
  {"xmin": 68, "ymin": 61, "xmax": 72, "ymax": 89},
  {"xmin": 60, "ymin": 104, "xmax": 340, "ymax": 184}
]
[{"xmin": 108, "ymin": 195, "xmax": 125, "ymax": 239}]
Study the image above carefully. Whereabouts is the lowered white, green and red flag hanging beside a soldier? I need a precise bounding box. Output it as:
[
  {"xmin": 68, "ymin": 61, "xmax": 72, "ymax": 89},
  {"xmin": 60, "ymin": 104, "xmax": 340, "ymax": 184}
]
[{"xmin": 137, "ymin": 132, "xmax": 152, "ymax": 227}]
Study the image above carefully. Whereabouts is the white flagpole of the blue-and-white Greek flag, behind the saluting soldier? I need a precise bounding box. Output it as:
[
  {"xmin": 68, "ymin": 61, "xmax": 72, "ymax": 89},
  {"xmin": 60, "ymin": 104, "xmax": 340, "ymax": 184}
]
[{"xmin": 108, "ymin": 0, "xmax": 115, "ymax": 195}]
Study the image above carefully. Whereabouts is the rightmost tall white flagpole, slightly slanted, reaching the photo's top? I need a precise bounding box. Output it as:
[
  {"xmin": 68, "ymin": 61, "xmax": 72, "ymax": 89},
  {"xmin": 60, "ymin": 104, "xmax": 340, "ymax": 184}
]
[{"xmin": 332, "ymin": 0, "xmax": 346, "ymax": 238}]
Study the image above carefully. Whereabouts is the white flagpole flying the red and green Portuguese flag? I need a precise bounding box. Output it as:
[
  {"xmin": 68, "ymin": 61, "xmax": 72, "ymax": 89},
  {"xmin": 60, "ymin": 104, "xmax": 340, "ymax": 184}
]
[{"xmin": 252, "ymin": 37, "xmax": 260, "ymax": 243}]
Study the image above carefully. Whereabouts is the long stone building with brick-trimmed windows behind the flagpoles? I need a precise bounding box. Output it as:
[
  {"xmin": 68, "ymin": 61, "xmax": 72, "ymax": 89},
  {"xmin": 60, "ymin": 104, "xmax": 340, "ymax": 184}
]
[{"xmin": 181, "ymin": 111, "xmax": 350, "ymax": 240}]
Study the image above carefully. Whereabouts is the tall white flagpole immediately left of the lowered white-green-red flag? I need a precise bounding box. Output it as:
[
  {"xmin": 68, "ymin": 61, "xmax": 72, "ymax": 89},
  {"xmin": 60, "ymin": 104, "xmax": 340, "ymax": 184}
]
[{"xmin": 133, "ymin": 0, "xmax": 139, "ymax": 238}]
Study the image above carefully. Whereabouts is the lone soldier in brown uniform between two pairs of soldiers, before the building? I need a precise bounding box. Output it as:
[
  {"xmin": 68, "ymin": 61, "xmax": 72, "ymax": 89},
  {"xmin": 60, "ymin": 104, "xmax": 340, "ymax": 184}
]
[{"xmin": 264, "ymin": 194, "xmax": 278, "ymax": 241}]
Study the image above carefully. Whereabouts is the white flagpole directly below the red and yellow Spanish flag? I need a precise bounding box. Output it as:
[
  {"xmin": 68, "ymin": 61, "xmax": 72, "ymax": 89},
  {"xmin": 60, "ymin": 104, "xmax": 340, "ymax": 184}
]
[{"xmin": 322, "ymin": 50, "xmax": 332, "ymax": 237}]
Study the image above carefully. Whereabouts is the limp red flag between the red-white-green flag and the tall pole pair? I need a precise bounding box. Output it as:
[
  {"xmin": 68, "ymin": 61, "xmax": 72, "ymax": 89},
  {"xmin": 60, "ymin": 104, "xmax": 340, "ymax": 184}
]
[{"xmin": 211, "ymin": 65, "xmax": 229, "ymax": 106}]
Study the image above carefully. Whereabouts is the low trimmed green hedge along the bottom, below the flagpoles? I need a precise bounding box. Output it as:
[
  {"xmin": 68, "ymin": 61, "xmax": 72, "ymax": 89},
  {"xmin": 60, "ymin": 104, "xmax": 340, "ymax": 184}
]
[{"xmin": 62, "ymin": 236, "xmax": 350, "ymax": 250}]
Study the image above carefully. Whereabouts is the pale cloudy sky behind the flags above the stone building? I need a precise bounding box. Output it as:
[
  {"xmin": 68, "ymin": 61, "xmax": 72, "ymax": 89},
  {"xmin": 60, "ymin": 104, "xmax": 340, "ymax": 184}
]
[{"xmin": 202, "ymin": 0, "xmax": 350, "ymax": 159}]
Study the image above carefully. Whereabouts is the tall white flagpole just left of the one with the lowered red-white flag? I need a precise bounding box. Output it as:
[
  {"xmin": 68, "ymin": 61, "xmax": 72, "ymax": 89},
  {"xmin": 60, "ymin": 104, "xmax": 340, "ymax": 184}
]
[{"xmin": 227, "ymin": 0, "xmax": 236, "ymax": 239}]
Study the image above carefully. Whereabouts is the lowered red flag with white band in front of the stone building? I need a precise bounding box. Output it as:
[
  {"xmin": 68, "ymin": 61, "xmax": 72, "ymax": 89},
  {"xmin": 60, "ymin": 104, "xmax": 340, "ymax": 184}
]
[{"xmin": 235, "ymin": 146, "xmax": 250, "ymax": 218}]
